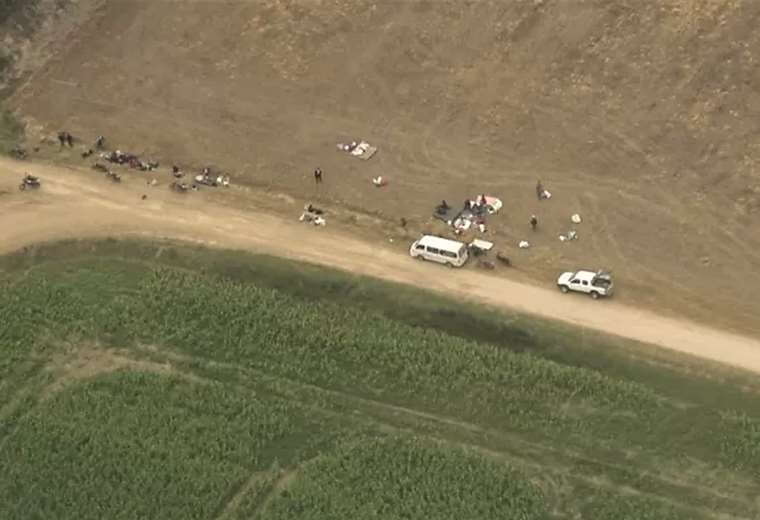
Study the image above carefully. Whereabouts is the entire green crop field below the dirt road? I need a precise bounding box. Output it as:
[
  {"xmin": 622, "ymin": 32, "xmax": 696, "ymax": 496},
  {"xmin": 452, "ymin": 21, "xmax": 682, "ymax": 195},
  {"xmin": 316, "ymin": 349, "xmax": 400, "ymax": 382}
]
[{"xmin": 0, "ymin": 240, "xmax": 760, "ymax": 520}]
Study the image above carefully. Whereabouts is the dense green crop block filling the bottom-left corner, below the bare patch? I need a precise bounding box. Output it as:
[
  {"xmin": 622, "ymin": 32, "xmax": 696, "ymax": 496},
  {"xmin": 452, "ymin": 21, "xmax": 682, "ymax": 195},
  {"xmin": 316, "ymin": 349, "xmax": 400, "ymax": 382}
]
[{"xmin": 0, "ymin": 372, "xmax": 298, "ymax": 519}]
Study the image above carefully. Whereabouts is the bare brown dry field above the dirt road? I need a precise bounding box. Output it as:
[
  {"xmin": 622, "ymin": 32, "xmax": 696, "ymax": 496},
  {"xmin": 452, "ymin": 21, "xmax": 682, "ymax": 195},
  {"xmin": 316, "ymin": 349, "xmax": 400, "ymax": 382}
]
[{"xmin": 5, "ymin": 0, "xmax": 760, "ymax": 332}]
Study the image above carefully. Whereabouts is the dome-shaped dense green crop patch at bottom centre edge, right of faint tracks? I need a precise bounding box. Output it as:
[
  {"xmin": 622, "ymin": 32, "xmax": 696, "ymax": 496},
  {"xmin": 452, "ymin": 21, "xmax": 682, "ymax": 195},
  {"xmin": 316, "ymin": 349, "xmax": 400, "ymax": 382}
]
[{"xmin": 261, "ymin": 437, "xmax": 547, "ymax": 520}]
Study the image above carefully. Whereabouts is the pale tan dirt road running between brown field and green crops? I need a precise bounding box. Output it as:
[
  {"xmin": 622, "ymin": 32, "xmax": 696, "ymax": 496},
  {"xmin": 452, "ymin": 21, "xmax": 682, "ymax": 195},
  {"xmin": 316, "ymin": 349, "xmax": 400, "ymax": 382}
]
[{"xmin": 0, "ymin": 159, "xmax": 760, "ymax": 372}]
